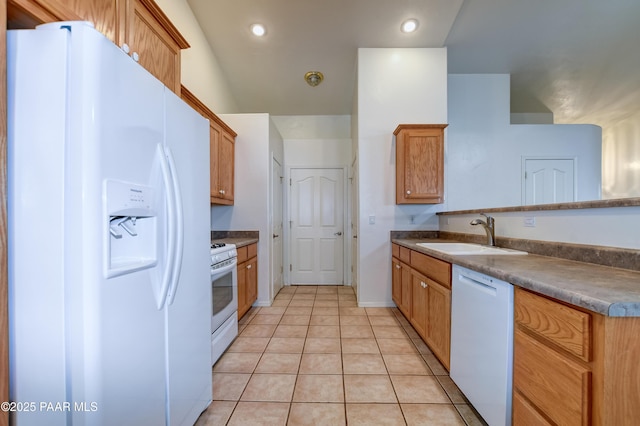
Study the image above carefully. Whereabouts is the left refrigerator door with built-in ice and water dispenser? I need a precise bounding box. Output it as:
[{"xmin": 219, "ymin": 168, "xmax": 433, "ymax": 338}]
[{"xmin": 65, "ymin": 21, "xmax": 166, "ymax": 425}]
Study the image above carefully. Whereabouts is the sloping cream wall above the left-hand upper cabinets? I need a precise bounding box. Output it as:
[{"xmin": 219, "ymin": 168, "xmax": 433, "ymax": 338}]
[{"xmin": 156, "ymin": 0, "xmax": 239, "ymax": 114}]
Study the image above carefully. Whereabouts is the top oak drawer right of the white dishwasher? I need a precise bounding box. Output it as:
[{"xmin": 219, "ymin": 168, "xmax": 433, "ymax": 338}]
[{"xmin": 514, "ymin": 289, "xmax": 591, "ymax": 361}]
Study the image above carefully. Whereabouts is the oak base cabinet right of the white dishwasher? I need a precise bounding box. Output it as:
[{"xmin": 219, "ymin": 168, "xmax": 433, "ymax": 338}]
[{"xmin": 513, "ymin": 288, "xmax": 640, "ymax": 425}]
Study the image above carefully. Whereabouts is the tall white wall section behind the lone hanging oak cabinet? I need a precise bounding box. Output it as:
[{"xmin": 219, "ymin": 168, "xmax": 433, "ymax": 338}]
[{"xmin": 357, "ymin": 48, "xmax": 447, "ymax": 306}]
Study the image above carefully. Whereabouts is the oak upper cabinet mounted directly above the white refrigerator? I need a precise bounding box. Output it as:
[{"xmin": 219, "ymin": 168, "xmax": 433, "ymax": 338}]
[{"xmin": 7, "ymin": 0, "xmax": 189, "ymax": 94}]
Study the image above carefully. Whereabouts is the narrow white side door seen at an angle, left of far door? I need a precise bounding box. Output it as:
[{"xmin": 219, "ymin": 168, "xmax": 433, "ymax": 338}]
[{"xmin": 271, "ymin": 157, "xmax": 284, "ymax": 296}]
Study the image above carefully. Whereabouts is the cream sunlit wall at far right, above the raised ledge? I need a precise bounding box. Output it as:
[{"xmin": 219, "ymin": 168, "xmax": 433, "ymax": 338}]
[{"xmin": 602, "ymin": 108, "xmax": 640, "ymax": 198}]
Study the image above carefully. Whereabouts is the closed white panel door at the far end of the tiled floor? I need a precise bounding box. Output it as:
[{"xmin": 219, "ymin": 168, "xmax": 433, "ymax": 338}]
[{"xmin": 289, "ymin": 168, "xmax": 344, "ymax": 285}]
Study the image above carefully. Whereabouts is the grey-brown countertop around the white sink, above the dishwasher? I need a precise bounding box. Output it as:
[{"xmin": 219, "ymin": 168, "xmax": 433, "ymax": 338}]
[{"xmin": 391, "ymin": 238, "xmax": 640, "ymax": 317}]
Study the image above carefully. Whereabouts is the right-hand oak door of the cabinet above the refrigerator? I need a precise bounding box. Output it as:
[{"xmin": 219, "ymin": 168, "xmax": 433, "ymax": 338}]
[{"xmin": 120, "ymin": 0, "xmax": 189, "ymax": 94}]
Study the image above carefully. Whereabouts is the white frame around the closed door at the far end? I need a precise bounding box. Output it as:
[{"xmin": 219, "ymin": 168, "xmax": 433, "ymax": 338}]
[{"xmin": 282, "ymin": 164, "xmax": 351, "ymax": 286}]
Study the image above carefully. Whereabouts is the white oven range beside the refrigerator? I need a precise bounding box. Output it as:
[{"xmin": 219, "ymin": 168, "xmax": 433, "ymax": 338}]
[{"xmin": 211, "ymin": 243, "xmax": 238, "ymax": 365}]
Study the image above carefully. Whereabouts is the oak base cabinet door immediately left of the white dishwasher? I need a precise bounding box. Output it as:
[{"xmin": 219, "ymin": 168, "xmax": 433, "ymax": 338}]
[{"xmin": 427, "ymin": 279, "xmax": 451, "ymax": 370}]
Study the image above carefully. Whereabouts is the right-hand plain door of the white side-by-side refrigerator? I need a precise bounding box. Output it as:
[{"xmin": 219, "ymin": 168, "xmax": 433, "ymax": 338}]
[{"xmin": 165, "ymin": 89, "xmax": 212, "ymax": 425}]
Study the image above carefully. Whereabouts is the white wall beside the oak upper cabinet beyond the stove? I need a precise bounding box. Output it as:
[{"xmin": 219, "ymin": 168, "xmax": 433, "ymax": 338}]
[{"xmin": 211, "ymin": 114, "xmax": 284, "ymax": 306}]
